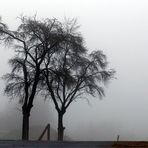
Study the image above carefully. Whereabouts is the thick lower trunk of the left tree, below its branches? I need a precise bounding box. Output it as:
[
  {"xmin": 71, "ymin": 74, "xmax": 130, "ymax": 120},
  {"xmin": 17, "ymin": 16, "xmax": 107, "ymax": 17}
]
[{"xmin": 22, "ymin": 113, "xmax": 29, "ymax": 140}]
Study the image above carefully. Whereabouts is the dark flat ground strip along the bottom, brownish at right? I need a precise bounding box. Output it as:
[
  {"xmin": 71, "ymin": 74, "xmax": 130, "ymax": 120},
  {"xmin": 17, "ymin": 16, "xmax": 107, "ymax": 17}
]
[{"xmin": 0, "ymin": 140, "xmax": 148, "ymax": 148}]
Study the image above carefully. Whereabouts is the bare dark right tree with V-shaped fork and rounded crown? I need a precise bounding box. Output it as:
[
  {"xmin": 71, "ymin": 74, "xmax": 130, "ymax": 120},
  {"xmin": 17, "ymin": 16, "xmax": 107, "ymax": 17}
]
[{"xmin": 41, "ymin": 21, "xmax": 114, "ymax": 140}]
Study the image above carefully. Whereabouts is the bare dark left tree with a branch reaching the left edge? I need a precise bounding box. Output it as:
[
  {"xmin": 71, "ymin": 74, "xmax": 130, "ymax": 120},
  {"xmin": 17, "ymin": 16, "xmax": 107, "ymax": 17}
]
[{"xmin": 0, "ymin": 17, "xmax": 65, "ymax": 140}]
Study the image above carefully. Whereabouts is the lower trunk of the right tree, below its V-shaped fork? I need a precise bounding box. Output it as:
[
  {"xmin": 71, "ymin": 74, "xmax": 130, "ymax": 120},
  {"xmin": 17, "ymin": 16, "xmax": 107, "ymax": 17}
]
[{"xmin": 58, "ymin": 113, "xmax": 65, "ymax": 141}]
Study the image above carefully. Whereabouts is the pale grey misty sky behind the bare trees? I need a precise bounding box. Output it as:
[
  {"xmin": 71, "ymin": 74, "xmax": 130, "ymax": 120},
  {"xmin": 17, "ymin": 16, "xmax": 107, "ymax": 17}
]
[{"xmin": 0, "ymin": 0, "xmax": 148, "ymax": 140}]
